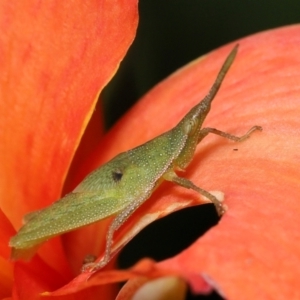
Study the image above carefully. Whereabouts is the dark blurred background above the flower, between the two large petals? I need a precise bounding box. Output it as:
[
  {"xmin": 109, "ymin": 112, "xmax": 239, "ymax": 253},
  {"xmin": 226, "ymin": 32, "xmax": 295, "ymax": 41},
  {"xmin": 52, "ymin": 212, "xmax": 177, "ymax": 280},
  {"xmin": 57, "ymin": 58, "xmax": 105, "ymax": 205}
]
[{"xmin": 101, "ymin": 0, "xmax": 300, "ymax": 129}]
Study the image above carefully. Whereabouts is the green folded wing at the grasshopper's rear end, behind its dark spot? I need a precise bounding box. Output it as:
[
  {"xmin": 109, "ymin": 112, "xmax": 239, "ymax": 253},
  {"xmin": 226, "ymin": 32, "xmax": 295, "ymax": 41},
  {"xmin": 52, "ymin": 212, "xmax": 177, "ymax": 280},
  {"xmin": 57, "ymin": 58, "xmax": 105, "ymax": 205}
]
[{"xmin": 9, "ymin": 192, "xmax": 126, "ymax": 260}]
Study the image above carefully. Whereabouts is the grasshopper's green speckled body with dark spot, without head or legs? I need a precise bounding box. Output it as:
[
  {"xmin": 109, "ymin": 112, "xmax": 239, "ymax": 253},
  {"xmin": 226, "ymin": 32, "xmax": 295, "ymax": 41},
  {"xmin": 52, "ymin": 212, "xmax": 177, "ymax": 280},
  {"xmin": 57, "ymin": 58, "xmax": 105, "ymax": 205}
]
[{"xmin": 10, "ymin": 104, "xmax": 206, "ymax": 254}]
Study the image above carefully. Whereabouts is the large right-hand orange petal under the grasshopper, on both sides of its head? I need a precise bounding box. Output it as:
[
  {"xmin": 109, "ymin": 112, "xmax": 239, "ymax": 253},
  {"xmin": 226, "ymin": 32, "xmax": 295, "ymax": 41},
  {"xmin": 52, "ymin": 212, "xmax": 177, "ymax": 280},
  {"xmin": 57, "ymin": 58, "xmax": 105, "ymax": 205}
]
[{"xmin": 62, "ymin": 25, "xmax": 300, "ymax": 299}]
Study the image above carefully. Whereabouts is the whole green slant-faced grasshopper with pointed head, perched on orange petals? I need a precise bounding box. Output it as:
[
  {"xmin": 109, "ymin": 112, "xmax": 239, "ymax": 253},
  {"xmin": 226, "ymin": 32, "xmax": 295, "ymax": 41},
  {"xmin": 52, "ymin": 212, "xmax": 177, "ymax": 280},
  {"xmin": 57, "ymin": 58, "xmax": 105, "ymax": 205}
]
[{"xmin": 9, "ymin": 45, "xmax": 262, "ymax": 272}]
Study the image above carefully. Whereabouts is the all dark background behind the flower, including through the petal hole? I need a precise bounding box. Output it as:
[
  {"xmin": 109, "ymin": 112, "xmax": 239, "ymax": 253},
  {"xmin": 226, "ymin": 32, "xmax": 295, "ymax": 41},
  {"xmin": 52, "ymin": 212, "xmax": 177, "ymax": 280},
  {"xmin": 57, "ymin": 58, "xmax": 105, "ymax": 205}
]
[{"xmin": 101, "ymin": 0, "xmax": 300, "ymax": 299}]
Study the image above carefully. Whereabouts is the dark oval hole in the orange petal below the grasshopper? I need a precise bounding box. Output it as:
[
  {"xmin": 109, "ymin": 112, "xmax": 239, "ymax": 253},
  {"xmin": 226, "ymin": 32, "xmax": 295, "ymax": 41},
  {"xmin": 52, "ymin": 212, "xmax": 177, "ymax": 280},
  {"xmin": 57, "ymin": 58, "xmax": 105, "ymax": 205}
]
[{"xmin": 119, "ymin": 204, "xmax": 219, "ymax": 268}]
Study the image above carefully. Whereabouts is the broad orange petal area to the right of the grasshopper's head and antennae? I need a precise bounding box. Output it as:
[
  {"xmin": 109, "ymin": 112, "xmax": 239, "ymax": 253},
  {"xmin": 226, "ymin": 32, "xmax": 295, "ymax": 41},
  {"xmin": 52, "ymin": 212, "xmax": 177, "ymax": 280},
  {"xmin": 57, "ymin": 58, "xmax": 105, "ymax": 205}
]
[{"xmin": 129, "ymin": 26, "xmax": 300, "ymax": 299}]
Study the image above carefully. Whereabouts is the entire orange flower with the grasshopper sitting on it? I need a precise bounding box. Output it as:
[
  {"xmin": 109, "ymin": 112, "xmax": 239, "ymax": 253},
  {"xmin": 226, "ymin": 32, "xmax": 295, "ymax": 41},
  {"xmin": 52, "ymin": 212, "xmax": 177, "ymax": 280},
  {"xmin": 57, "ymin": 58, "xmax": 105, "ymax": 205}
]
[{"xmin": 0, "ymin": 0, "xmax": 300, "ymax": 299}]
